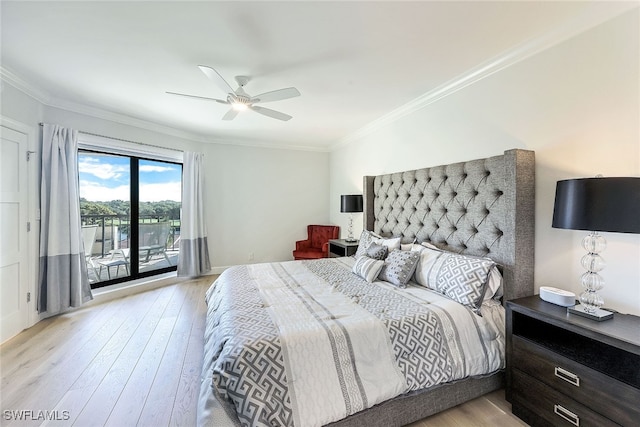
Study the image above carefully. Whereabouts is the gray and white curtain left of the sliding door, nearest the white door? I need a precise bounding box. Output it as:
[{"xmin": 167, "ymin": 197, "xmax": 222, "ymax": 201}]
[{"xmin": 38, "ymin": 124, "xmax": 93, "ymax": 318}]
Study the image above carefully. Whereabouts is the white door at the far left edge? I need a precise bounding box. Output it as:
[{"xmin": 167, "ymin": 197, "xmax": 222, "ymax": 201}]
[{"xmin": 0, "ymin": 126, "xmax": 29, "ymax": 342}]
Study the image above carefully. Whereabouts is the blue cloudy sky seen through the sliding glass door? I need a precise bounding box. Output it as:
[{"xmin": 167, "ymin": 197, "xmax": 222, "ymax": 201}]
[{"xmin": 78, "ymin": 153, "xmax": 182, "ymax": 202}]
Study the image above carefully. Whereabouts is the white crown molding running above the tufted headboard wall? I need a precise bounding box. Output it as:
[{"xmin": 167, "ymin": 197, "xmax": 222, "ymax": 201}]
[{"xmin": 329, "ymin": 2, "xmax": 639, "ymax": 151}]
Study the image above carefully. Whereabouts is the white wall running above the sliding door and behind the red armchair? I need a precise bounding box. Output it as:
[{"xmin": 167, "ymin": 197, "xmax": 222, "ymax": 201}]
[{"xmin": 1, "ymin": 83, "xmax": 329, "ymax": 278}]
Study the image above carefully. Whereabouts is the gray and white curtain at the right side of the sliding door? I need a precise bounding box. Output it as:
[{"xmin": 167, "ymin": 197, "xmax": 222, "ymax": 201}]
[{"xmin": 178, "ymin": 151, "xmax": 211, "ymax": 277}]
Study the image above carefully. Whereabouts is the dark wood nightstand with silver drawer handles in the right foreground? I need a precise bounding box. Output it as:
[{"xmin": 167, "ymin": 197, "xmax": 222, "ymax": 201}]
[{"xmin": 506, "ymin": 295, "xmax": 640, "ymax": 427}]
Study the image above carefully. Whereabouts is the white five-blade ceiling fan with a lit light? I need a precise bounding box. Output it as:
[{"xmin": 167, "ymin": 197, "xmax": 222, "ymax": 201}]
[{"xmin": 167, "ymin": 65, "xmax": 300, "ymax": 121}]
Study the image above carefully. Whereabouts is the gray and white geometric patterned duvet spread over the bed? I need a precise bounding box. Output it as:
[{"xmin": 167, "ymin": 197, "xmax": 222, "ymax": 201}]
[{"xmin": 198, "ymin": 258, "xmax": 504, "ymax": 426}]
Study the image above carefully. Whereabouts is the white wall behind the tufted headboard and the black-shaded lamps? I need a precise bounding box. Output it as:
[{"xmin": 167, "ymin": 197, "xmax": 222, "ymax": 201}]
[{"xmin": 330, "ymin": 8, "xmax": 640, "ymax": 314}]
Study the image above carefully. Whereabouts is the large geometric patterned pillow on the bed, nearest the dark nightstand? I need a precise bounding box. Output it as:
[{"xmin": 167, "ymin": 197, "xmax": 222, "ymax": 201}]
[{"xmin": 415, "ymin": 248, "xmax": 496, "ymax": 312}]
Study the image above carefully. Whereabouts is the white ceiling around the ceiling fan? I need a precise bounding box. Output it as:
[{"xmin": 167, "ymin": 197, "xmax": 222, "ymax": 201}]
[{"xmin": 0, "ymin": 1, "xmax": 637, "ymax": 150}]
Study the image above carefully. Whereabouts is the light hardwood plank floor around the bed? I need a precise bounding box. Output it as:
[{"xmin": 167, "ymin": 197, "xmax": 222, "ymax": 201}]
[{"xmin": 0, "ymin": 278, "xmax": 526, "ymax": 427}]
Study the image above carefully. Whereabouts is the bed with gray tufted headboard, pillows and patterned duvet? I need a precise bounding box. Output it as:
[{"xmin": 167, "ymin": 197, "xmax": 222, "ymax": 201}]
[{"xmin": 198, "ymin": 149, "xmax": 534, "ymax": 426}]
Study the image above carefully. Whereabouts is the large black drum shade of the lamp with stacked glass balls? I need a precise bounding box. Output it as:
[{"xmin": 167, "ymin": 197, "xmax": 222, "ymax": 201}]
[{"xmin": 552, "ymin": 177, "xmax": 640, "ymax": 233}]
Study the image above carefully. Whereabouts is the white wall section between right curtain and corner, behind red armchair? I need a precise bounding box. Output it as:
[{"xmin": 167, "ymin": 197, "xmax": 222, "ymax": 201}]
[{"xmin": 202, "ymin": 144, "xmax": 329, "ymax": 266}]
